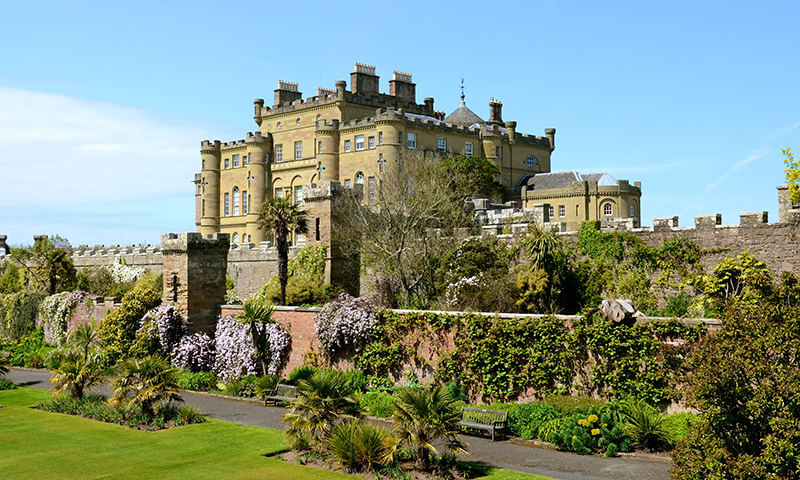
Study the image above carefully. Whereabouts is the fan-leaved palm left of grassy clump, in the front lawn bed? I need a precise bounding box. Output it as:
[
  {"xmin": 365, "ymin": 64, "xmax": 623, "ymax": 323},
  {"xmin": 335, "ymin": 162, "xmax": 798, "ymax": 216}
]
[{"xmin": 283, "ymin": 370, "xmax": 363, "ymax": 449}]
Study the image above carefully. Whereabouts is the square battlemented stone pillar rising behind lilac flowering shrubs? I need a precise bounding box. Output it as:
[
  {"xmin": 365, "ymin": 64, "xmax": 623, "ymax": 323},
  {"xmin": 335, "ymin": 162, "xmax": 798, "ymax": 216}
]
[{"xmin": 161, "ymin": 232, "xmax": 230, "ymax": 335}]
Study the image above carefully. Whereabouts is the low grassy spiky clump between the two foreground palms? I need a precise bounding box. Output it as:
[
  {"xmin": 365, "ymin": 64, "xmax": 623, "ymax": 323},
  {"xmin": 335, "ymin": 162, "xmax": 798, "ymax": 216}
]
[{"xmin": 325, "ymin": 420, "xmax": 389, "ymax": 472}]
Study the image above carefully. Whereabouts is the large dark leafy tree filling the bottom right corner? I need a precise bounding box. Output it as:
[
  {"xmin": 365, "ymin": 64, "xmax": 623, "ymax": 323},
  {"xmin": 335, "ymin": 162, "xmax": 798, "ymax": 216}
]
[{"xmin": 672, "ymin": 274, "xmax": 800, "ymax": 480}]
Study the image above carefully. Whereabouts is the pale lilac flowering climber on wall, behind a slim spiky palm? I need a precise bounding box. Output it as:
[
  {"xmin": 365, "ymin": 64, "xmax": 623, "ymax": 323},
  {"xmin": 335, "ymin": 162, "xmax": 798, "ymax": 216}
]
[{"xmin": 214, "ymin": 315, "xmax": 289, "ymax": 383}]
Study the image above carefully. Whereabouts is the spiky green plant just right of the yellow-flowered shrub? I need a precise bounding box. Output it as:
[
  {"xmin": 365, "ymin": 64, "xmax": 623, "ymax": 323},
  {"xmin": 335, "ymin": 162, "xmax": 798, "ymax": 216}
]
[{"xmin": 620, "ymin": 398, "xmax": 675, "ymax": 451}]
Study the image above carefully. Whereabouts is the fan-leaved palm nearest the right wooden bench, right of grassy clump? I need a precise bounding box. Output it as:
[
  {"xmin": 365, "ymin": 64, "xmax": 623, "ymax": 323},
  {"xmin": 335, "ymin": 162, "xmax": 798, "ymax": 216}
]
[{"xmin": 392, "ymin": 385, "xmax": 466, "ymax": 471}]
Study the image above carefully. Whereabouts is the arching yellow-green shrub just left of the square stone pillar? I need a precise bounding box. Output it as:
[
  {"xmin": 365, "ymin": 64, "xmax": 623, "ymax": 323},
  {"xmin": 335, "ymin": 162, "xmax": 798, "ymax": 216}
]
[{"xmin": 97, "ymin": 286, "xmax": 162, "ymax": 362}]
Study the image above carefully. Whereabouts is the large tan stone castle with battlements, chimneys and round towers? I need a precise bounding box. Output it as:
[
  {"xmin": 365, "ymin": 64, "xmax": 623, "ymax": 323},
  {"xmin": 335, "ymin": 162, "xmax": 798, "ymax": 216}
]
[{"xmin": 194, "ymin": 63, "xmax": 641, "ymax": 245}]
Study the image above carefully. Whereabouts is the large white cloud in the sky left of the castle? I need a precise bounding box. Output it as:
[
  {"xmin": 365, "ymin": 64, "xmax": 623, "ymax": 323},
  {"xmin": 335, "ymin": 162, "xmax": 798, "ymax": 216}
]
[{"xmin": 0, "ymin": 87, "xmax": 238, "ymax": 208}]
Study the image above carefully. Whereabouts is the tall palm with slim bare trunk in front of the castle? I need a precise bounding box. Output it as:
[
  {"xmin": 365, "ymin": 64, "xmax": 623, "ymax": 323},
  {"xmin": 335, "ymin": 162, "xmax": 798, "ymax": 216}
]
[{"xmin": 258, "ymin": 198, "xmax": 308, "ymax": 305}]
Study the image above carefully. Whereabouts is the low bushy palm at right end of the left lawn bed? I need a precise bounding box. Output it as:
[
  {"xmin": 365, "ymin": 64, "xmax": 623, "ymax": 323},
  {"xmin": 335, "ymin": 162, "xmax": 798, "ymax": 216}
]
[{"xmin": 110, "ymin": 355, "xmax": 183, "ymax": 416}]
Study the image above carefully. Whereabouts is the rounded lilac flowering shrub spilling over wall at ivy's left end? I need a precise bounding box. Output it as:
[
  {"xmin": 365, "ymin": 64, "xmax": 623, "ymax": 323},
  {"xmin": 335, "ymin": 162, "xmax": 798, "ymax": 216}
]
[{"xmin": 314, "ymin": 293, "xmax": 376, "ymax": 357}]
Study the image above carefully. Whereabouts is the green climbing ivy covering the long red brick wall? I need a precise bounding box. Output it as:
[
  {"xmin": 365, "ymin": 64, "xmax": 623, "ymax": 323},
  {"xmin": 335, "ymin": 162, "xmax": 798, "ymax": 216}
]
[{"xmin": 355, "ymin": 311, "xmax": 704, "ymax": 402}]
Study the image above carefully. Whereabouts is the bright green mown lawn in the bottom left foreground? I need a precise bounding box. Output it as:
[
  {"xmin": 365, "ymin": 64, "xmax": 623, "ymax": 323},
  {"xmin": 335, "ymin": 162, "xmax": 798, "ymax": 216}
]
[{"xmin": 0, "ymin": 387, "xmax": 547, "ymax": 480}]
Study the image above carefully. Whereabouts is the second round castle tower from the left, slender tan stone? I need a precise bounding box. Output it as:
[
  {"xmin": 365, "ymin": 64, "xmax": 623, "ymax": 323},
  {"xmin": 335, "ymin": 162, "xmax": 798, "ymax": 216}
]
[{"xmin": 246, "ymin": 132, "xmax": 272, "ymax": 243}]
